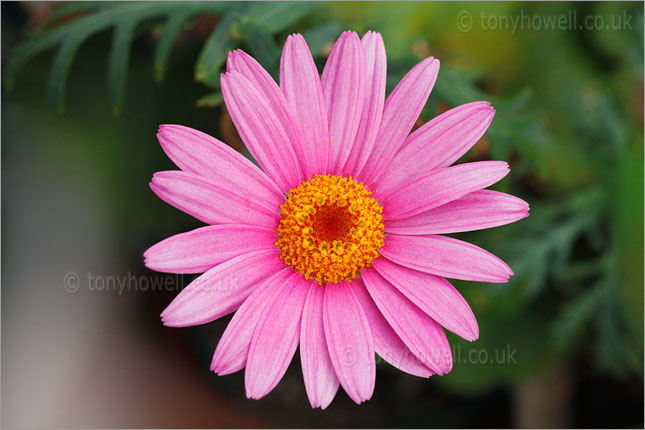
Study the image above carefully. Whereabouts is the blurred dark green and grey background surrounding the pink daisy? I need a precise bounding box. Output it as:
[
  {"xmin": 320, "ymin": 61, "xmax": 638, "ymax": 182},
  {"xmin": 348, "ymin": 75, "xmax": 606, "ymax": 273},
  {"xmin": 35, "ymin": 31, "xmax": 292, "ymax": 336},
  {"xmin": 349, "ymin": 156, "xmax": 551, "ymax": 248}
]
[{"xmin": 1, "ymin": 2, "xmax": 644, "ymax": 428}]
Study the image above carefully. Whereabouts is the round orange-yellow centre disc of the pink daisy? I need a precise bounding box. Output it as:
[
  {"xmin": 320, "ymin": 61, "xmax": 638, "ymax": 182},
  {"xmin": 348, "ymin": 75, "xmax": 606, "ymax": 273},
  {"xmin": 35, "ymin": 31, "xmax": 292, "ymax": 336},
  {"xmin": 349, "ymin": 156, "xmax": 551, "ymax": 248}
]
[{"xmin": 276, "ymin": 175, "xmax": 383, "ymax": 284}]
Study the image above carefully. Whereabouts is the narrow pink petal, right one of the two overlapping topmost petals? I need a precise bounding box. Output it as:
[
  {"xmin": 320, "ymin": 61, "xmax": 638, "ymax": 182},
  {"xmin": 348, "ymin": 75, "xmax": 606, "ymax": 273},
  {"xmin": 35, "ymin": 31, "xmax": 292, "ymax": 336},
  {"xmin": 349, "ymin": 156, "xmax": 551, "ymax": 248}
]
[{"xmin": 342, "ymin": 31, "xmax": 387, "ymax": 176}]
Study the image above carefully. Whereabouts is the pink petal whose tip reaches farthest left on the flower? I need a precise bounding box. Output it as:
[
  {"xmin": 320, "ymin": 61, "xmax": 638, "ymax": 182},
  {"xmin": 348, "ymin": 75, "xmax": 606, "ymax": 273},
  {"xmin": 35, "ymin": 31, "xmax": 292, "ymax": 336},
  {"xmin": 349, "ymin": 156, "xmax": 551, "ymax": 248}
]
[{"xmin": 143, "ymin": 224, "xmax": 276, "ymax": 273}]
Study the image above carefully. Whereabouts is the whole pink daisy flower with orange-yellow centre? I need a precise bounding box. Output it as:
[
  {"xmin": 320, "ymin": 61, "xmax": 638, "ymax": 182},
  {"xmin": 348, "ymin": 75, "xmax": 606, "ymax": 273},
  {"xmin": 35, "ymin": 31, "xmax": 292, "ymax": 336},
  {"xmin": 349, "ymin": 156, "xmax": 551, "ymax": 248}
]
[{"xmin": 144, "ymin": 32, "xmax": 529, "ymax": 408}]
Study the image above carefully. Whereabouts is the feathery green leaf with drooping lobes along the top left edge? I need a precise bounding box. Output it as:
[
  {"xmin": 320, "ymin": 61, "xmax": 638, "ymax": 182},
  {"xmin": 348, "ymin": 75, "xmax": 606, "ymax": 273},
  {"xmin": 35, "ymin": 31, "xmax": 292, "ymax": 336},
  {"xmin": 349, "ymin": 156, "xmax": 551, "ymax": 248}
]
[{"xmin": 4, "ymin": 2, "xmax": 322, "ymax": 113}]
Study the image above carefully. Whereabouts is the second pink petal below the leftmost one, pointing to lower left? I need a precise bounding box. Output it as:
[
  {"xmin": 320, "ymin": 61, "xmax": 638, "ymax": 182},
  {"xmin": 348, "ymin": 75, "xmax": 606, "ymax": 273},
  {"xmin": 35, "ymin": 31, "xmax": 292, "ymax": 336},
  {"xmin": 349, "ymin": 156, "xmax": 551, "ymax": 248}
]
[{"xmin": 211, "ymin": 267, "xmax": 293, "ymax": 375}]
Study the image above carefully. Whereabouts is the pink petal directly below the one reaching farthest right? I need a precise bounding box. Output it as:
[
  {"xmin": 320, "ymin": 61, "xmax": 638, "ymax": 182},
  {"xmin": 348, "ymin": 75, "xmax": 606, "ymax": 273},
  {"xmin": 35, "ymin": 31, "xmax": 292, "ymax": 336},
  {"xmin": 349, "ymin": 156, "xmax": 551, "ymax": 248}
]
[{"xmin": 379, "ymin": 233, "xmax": 513, "ymax": 283}]
